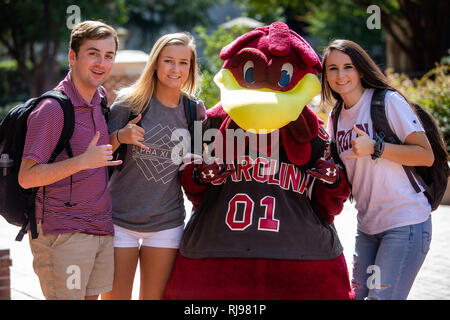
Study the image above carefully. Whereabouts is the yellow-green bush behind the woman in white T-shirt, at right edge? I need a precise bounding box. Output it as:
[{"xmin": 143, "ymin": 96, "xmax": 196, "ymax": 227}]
[{"xmin": 386, "ymin": 64, "xmax": 450, "ymax": 151}]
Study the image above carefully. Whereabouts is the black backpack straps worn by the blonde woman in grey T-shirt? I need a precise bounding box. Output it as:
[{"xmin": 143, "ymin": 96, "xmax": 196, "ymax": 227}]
[{"xmin": 108, "ymin": 94, "xmax": 197, "ymax": 177}]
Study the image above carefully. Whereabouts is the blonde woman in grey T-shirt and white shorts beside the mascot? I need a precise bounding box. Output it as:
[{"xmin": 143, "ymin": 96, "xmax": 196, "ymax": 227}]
[{"xmin": 103, "ymin": 33, "xmax": 205, "ymax": 299}]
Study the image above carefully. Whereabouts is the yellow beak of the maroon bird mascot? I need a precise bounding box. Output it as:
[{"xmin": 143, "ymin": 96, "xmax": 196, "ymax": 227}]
[{"xmin": 214, "ymin": 69, "xmax": 321, "ymax": 133}]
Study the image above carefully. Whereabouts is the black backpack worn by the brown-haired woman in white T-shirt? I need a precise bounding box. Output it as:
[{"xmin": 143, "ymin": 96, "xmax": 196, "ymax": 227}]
[{"xmin": 331, "ymin": 89, "xmax": 450, "ymax": 211}]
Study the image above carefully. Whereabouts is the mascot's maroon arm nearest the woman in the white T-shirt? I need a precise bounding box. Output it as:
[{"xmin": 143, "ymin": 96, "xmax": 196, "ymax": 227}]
[{"xmin": 311, "ymin": 170, "xmax": 350, "ymax": 224}]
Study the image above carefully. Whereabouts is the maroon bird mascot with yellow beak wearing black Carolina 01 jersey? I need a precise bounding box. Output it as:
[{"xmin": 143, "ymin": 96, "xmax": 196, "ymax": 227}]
[{"xmin": 165, "ymin": 22, "xmax": 353, "ymax": 299}]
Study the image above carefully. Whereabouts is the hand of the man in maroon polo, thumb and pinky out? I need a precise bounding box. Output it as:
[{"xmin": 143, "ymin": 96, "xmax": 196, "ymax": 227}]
[{"xmin": 81, "ymin": 131, "xmax": 122, "ymax": 169}]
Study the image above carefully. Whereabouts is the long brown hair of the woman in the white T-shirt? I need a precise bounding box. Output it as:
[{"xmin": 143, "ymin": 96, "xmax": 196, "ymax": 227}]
[{"xmin": 321, "ymin": 39, "xmax": 398, "ymax": 105}]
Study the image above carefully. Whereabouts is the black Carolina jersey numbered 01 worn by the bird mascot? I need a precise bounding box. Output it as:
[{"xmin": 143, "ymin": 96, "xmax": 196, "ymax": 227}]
[{"xmin": 181, "ymin": 119, "xmax": 342, "ymax": 260}]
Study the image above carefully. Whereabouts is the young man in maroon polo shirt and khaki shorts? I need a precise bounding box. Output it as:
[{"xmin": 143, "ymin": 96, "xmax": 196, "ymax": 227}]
[{"xmin": 19, "ymin": 21, "xmax": 121, "ymax": 299}]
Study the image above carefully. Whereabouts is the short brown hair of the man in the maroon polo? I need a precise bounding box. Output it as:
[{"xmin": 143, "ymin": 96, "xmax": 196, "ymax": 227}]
[{"xmin": 69, "ymin": 20, "xmax": 119, "ymax": 54}]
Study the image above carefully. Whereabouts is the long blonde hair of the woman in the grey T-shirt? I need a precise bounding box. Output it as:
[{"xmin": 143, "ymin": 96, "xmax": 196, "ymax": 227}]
[{"xmin": 116, "ymin": 32, "xmax": 200, "ymax": 114}]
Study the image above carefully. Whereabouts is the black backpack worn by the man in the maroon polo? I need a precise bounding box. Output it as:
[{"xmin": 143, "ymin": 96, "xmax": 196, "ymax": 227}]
[{"xmin": 0, "ymin": 88, "xmax": 109, "ymax": 241}]
